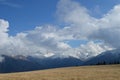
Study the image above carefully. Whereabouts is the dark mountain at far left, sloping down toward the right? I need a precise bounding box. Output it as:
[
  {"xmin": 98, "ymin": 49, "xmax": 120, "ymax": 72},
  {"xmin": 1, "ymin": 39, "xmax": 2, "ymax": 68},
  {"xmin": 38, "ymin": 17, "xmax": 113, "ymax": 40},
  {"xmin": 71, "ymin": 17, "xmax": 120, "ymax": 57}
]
[{"xmin": 0, "ymin": 55, "xmax": 42, "ymax": 73}]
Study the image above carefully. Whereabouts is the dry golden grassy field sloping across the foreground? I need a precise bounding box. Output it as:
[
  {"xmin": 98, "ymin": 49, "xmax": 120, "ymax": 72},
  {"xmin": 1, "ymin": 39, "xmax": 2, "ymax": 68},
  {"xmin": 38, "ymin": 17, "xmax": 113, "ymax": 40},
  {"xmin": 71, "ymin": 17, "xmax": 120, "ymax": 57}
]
[{"xmin": 0, "ymin": 65, "xmax": 120, "ymax": 80}]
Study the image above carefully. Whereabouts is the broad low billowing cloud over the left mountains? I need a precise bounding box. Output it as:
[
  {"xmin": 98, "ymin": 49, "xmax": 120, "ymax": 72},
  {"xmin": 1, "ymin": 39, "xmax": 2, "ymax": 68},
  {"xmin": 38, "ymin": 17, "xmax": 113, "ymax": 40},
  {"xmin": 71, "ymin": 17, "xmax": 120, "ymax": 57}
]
[{"xmin": 0, "ymin": 23, "xmax": 70, "ymax": 57}]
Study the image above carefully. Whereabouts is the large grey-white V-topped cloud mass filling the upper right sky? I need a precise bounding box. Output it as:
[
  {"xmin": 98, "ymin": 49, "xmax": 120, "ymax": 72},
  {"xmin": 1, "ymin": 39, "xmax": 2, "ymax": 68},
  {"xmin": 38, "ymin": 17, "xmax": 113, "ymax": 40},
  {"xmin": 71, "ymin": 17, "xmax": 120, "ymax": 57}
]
[{"xmin": 57, "ymin": 0, "xmax": 120, "ymax": 48}]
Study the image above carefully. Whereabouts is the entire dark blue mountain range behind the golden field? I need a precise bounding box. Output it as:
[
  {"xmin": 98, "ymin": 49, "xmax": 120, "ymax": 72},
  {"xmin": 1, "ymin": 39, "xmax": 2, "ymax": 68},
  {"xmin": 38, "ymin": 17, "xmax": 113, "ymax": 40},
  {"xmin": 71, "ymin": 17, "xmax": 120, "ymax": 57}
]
[{"xmin": 0, "ymin": 49, "xmax": 120, "ymax": 73}]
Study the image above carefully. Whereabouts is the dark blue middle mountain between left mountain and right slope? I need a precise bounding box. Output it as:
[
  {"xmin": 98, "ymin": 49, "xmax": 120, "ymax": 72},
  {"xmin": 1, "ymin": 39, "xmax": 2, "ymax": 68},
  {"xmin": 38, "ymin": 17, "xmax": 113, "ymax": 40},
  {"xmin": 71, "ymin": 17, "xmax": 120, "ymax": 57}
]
[{"xmin": 29, "ymin": 57, "xmax": 83, "ymax": 69}]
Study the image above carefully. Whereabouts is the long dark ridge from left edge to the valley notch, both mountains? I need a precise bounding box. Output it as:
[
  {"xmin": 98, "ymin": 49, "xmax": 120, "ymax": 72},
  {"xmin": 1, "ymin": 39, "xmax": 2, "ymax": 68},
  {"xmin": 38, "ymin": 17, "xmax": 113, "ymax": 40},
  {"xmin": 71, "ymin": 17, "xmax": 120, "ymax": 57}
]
[{"xmin": 0, "ymin": 55, "xmax": 82, "ymax": 73}]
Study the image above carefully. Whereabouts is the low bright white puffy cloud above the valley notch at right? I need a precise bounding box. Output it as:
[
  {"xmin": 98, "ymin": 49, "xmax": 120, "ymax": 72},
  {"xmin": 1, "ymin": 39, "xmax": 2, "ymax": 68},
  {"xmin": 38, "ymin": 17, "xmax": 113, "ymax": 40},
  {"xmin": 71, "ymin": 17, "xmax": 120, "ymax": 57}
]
[{"xmin": 62, "ymin": 41, "xmax": 113, "ymax": 60}]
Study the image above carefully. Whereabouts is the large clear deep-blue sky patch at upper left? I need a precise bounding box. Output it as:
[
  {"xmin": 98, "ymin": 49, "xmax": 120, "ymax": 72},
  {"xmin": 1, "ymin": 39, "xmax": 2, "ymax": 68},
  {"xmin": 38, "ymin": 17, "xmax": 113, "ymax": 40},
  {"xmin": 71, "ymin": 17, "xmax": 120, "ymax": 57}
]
[{"xmin": 0, "ymin": 0, "xmax": 57, "ymax": 35}]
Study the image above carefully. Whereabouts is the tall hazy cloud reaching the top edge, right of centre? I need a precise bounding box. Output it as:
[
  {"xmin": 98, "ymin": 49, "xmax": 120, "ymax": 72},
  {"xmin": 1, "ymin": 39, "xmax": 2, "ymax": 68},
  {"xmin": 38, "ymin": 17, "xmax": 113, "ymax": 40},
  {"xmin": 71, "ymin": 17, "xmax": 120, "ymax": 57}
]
[{"xmin": 57, "ymin": 0, "xmax": 97, "ymax": 39}]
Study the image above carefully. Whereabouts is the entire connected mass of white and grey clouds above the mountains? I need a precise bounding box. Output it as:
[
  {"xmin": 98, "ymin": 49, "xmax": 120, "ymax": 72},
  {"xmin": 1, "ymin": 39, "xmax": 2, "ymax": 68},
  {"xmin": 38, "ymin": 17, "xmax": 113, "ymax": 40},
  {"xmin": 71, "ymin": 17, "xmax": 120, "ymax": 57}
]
[{"xmin": 0, "ymin": 0, "xmax": 120, "ymax": 60}]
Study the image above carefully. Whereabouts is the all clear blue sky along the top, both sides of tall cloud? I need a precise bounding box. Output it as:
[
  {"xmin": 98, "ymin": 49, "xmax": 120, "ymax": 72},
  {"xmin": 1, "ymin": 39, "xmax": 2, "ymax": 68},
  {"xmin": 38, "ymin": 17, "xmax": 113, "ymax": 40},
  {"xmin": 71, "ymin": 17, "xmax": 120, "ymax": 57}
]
[{"xmin": 0, "ymin": 0, "xmax": 120, "ymax": 35}]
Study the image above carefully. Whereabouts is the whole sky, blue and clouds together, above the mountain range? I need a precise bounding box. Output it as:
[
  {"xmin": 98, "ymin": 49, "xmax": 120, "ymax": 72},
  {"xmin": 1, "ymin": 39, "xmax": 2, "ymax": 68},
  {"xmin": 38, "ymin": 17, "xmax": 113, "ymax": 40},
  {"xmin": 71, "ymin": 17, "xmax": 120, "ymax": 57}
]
[{"xmin": 0, "ymin": 0, "xmax": 120, "ymax": 59}]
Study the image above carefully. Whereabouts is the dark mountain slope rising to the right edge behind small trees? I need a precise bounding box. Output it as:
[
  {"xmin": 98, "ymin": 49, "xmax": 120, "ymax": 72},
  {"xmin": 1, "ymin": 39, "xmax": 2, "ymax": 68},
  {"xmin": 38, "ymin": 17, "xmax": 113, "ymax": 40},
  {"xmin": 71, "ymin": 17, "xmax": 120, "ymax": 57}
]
[{"xmin": 84, "ymin": 49, "xmax": 120, "ymax": 65}]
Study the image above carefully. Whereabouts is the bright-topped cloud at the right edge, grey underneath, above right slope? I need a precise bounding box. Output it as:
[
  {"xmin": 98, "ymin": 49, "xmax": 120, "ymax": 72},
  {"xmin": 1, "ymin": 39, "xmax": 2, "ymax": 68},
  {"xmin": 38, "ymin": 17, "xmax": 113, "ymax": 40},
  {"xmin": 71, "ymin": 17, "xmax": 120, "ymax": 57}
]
[{"xmin": 92, "ymin": 5, "xmax": 120, "ymax": 48}]
